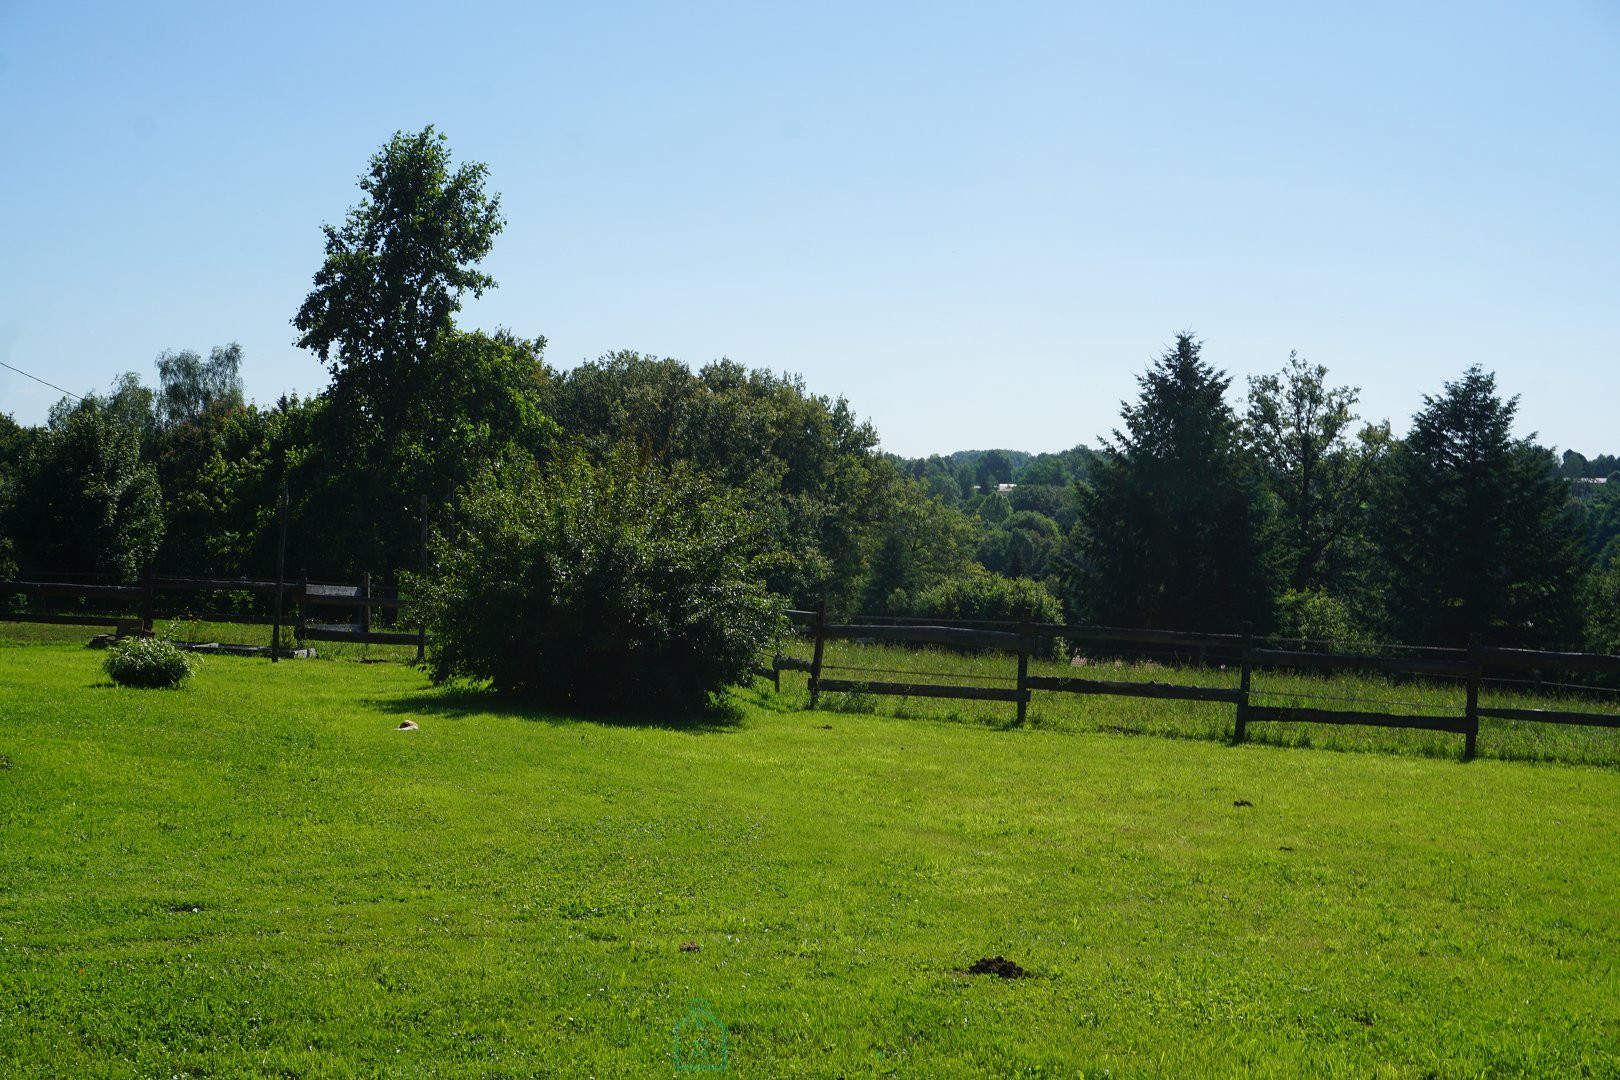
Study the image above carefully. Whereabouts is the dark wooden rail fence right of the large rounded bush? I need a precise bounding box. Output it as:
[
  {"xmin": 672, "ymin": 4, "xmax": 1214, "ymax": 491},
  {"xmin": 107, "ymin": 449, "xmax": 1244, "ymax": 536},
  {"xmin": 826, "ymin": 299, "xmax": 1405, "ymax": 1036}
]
[{"xmin": 771, "ymin": 610, "xmax": 1620, "ymax": 758}]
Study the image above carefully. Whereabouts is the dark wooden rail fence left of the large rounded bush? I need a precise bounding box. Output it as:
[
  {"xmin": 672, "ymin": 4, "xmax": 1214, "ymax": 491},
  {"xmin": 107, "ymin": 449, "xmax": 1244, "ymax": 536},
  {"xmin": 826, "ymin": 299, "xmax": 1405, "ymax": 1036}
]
[{"xmin": 0, "ymin": 575, "xmax": 426, "ymax": 661}]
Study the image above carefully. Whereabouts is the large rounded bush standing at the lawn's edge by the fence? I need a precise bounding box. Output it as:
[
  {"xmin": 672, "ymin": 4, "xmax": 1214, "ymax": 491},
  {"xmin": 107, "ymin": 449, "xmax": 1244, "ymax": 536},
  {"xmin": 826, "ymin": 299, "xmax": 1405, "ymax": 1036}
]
[{"xmin": 420, "ymin": 447, "xmax": 782, "ymax": 711}]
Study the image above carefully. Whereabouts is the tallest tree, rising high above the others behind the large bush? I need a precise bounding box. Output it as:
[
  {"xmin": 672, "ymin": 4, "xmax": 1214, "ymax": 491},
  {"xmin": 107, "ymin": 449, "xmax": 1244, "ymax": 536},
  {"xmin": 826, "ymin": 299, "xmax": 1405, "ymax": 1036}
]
[{"xmin": 290, "ymin": 126, "xmax": 556, "ymax": 575}]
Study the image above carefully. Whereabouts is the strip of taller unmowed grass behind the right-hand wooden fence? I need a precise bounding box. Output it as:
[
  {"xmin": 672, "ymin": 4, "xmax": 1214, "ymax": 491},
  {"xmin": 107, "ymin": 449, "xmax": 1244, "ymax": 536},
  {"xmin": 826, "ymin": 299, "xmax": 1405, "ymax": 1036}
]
[{"xmin": 773, "ymin": 612, "xmax": 1620, "ymax": 764}]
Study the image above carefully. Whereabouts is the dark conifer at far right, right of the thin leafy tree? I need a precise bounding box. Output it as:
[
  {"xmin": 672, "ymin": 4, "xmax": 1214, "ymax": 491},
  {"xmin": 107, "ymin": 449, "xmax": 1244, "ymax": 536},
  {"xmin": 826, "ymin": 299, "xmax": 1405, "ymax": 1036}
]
[{"xmin": 1380, "ymin": 366, "xmax": 1586, "ymax": 646}]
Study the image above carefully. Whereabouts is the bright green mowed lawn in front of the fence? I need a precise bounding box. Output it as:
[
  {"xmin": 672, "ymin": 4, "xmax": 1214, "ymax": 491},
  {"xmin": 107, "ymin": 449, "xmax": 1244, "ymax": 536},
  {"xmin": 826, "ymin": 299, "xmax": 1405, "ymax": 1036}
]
[{"xmin": 0, "ymin": 644, "xmax": 1620, "ymax": 1077}]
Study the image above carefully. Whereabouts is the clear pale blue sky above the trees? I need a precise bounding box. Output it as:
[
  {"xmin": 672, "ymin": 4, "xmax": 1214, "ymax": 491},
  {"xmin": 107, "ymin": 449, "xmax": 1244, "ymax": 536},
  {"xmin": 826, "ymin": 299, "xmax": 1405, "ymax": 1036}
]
[{"xmin": 0, "ymin": 0, "xmax": 1620, "ymax": 455}]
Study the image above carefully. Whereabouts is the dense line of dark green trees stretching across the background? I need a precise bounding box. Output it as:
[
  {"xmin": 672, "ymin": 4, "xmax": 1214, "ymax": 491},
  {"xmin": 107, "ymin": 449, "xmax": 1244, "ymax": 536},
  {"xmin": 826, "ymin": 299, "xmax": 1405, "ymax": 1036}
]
[{"xmin": 0, "ymin": 128, "xmax": 1620, "ymax": 654}]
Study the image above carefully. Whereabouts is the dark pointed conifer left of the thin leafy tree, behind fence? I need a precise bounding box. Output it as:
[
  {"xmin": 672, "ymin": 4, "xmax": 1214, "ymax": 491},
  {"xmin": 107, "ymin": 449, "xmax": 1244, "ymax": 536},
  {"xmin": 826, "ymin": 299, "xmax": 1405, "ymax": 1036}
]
[{"xmin": 1068, "ymin": 334, "xmax": 1272, "ymax": 630}]
